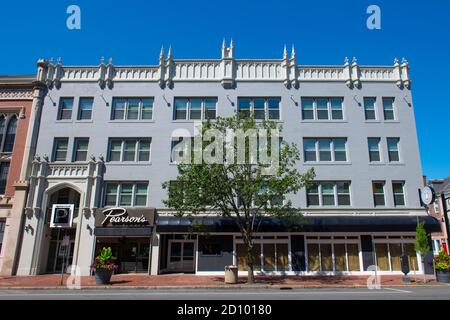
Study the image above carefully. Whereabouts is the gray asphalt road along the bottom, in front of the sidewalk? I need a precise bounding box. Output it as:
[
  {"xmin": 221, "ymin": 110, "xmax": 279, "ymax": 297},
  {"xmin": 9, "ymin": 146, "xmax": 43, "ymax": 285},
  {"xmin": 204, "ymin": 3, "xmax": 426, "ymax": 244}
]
[{"xmin": 0, "ymin": 285, "xmax": 450, "ymax": 301}]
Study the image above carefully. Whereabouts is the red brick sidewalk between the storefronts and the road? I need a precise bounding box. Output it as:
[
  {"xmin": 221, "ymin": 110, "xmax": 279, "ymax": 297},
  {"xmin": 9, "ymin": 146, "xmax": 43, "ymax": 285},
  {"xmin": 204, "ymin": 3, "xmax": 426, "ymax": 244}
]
[{"xmin": 0, "ymin": 274, "xmax": 445, "ymax": 289}]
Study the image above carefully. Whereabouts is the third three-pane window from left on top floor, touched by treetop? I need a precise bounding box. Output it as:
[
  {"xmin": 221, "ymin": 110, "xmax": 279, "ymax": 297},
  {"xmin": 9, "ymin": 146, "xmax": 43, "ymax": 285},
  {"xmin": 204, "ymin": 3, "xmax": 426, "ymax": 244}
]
[{"xmin": 238, "ymin": 98, "xmax": 281, "ymax": 120}]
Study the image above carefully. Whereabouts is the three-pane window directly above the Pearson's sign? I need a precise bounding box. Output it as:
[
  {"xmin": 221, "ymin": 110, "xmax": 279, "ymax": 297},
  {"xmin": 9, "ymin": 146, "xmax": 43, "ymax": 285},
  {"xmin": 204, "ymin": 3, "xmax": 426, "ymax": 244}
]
[{"xmin": 105, "ymin": 182, "xmax": 148, "ymax": 207}]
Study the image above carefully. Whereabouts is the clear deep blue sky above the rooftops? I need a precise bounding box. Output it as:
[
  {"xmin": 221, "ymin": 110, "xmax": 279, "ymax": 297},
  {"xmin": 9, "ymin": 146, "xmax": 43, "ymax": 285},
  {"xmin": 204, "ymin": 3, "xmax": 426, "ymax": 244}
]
[{"xmin": 0, "ymin": 0, "xmax": 450, "ymax": 178}]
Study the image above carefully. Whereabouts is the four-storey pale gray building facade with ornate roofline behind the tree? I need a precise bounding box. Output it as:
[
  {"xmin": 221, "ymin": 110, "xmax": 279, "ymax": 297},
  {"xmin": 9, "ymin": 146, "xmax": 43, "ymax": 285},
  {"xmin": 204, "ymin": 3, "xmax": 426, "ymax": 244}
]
[{"xmin": 14, "ymin": 42, "xmax": 439, "ymax": 275}]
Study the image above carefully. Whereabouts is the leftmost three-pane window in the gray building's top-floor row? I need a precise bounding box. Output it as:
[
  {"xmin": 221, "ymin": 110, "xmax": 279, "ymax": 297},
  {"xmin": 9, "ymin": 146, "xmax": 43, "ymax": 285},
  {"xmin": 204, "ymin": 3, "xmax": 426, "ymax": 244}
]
[{"xmin": 111, "ymin": 98, "xmax": 153, "ymax": 120}]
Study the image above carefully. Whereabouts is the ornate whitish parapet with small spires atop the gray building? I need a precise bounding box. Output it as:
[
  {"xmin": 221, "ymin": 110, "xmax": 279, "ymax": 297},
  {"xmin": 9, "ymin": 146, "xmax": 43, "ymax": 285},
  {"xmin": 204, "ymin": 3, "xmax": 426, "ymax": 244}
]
[{"xmin": 37, "ymin": 42, "xmax": 411, "ymax": 89}]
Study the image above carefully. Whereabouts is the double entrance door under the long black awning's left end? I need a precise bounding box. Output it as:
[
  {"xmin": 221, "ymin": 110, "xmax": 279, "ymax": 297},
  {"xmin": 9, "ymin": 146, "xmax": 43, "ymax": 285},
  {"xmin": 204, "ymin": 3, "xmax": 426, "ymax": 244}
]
[{"xmin": 167, "ymin": 240, "xmax": 195, "ymax": 272}]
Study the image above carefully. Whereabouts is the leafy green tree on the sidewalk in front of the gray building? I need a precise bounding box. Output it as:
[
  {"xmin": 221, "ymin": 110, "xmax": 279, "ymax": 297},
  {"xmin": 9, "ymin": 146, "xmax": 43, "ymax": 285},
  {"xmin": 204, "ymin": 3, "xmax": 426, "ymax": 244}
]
[{"xmin": 163, "ymin": 114, "xmax": 315, "ymax": 283}]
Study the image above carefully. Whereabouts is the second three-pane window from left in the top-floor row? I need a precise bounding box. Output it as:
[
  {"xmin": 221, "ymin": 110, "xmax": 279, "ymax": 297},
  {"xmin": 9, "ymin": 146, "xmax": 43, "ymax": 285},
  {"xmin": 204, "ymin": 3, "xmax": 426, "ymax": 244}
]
[{"xmin": 173, "ymin": 98, "xmax": 217, "ymax": 120}]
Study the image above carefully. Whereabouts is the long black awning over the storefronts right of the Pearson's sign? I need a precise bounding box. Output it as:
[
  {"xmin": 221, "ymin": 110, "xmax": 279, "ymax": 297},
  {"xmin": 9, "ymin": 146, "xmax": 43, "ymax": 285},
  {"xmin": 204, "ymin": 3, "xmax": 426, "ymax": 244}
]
[{"xmin": 156, "ymin": 216, "xmax": 441, "ymax": 233}]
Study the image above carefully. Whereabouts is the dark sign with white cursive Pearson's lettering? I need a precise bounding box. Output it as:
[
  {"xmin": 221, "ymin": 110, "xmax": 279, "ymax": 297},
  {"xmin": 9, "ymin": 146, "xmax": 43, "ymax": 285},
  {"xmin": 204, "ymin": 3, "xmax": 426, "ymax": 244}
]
[{"xmin": 95, "ymin": 207, "xmax": 155, "ymax": 227}]
